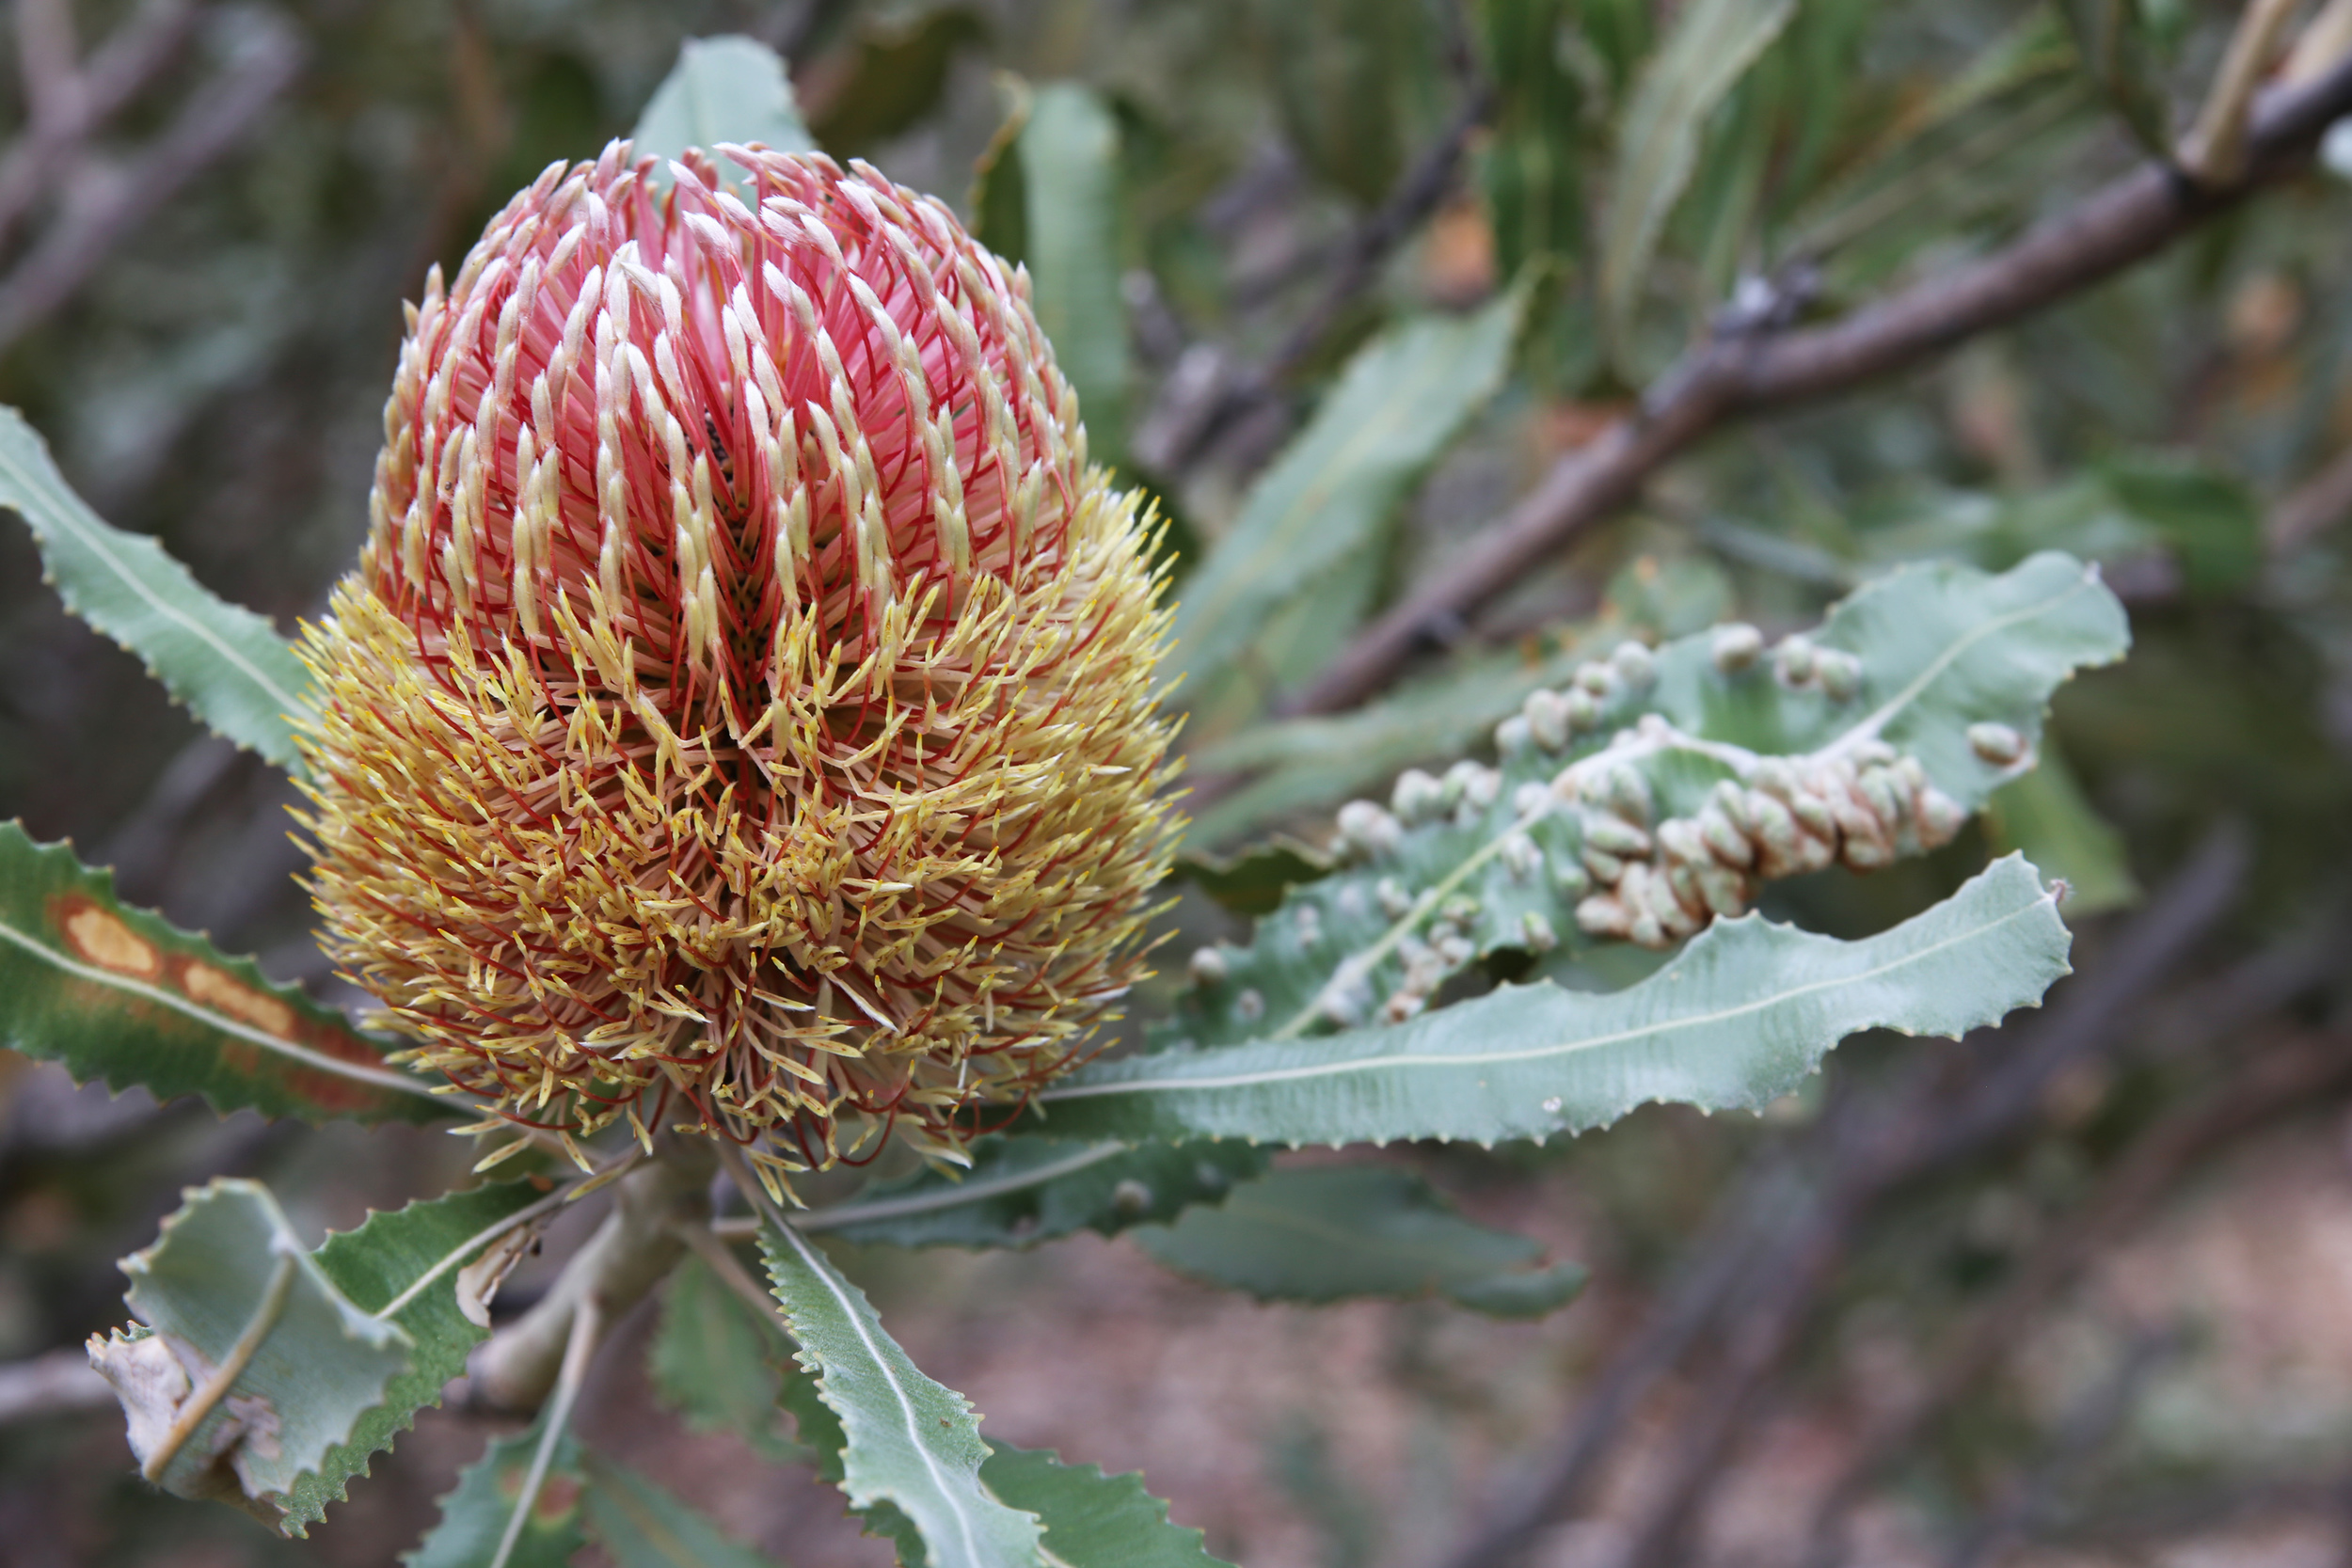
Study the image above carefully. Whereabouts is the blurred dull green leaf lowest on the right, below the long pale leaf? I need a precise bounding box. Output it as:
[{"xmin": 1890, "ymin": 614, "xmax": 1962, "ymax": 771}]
[{"xmin": 1134, "ymin": 1166, "xmax": 1585, "ymax": 1317}]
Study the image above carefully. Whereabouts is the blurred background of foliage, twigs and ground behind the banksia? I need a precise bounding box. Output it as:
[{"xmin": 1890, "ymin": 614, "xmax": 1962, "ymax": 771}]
[{"xmin": 0, "ymin": 0, "xmax": 2352, "ymax": 1568}]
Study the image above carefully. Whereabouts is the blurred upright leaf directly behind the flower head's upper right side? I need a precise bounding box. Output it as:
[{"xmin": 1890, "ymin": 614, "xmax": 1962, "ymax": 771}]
[{"xmin": 1014, "ymin": 82, "xmax": 1127, "ymax": 466}]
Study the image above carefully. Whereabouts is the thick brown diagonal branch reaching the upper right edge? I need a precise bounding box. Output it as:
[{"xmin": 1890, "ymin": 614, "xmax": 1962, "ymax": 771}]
[{"xmin": 1284, "ymin": 42, "xmax": 2352, "ymax": 712}]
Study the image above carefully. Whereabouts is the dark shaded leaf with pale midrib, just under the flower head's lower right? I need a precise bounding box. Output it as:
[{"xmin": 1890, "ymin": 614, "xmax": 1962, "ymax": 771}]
[{"xmin": 800, "ymin": 1135, "xmax": 1265, "ymax": 1246}]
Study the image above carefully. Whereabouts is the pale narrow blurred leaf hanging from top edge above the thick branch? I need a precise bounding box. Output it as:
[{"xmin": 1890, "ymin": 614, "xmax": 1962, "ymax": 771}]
[{"xmin": 1599, "ymin": 0, "xmax": 1797, "ymax": 381}]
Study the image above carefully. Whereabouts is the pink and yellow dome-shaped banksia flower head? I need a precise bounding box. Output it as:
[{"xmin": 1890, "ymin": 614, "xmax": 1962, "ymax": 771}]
[{"xmin": 292, "ymin": 143, "xmax": 1176, "ymax": 1171}]
